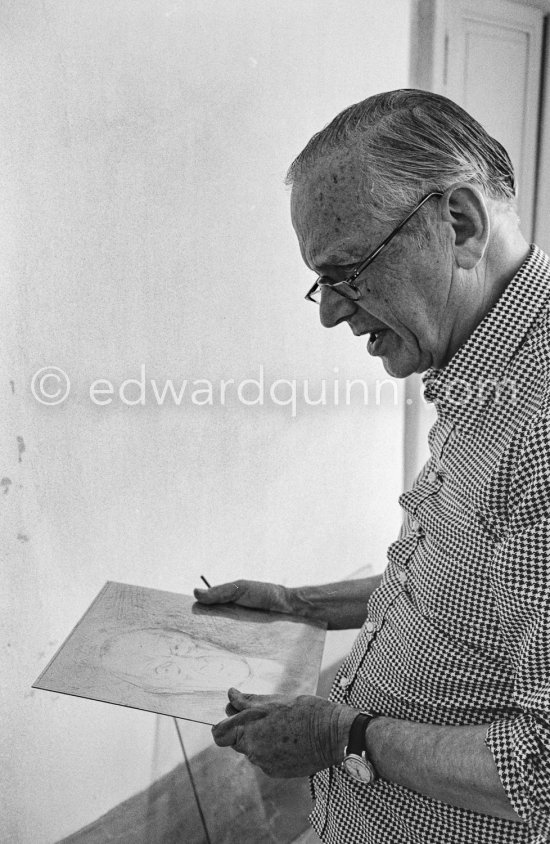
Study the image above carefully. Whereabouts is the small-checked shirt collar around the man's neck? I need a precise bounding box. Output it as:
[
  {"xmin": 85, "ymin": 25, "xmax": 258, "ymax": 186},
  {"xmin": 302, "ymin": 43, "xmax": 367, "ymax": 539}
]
[{"xmin": 422, "ymin": 244, "xmax": 550, "ymax": 410}]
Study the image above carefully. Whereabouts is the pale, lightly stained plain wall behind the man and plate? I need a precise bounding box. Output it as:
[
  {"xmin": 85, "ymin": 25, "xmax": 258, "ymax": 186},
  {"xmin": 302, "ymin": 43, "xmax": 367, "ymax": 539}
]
[{"xmin": 0, "ymin": 0, "xmax": 409, "ymax": 844}]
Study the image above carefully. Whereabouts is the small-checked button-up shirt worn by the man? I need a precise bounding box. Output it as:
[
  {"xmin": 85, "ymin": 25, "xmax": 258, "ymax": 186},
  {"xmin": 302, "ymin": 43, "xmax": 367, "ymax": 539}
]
[{"xmin": 310, "ymin": 246, "xmax": 550, "ymax": 844}]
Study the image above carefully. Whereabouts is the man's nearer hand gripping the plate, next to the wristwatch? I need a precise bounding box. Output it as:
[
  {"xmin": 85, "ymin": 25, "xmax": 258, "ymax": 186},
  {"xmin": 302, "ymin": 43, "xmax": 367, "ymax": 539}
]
[{"xmin": 212, "ymin": 689, "xmax": 359, "ymax": 777}]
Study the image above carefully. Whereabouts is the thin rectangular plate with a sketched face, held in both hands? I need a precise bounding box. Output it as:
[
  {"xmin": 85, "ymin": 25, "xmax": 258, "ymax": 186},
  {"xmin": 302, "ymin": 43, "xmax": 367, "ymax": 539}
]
[{"xmin": 33, "ymin": 581, "xmax": 325, "ymax": 724}]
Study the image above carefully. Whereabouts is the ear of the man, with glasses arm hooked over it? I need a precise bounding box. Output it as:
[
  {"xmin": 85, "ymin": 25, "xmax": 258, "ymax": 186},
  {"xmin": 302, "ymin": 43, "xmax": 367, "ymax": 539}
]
[{"xmin": 440, "ymin": 183, "xmax": 490, "ymax": 270}]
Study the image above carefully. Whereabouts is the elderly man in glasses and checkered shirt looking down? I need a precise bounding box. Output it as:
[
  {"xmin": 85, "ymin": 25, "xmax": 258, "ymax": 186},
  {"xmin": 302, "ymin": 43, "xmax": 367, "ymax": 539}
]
[{"xmin": 196, "ymin": 90, "xmax": 550, "ymax": 844}]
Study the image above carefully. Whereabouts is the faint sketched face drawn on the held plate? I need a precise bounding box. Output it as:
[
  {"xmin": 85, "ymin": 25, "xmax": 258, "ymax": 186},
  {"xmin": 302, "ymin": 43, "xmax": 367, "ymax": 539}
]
[{"xmin": 99, "ymin": 627, "xmax": 251, "ymax": 695}]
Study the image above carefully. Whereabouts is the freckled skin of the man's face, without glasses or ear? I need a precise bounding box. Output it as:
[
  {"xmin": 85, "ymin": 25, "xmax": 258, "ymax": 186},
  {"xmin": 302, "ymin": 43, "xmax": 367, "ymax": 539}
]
[{"xmin": 292, "ymin": 151, "xmax": 496, "ymax": 378}]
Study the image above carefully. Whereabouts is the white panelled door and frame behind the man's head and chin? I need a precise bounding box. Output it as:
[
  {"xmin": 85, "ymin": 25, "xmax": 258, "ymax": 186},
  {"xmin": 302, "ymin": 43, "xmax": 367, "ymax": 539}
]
[{"xmin": 404, "ymin": 0, "xmax": 550, "ymax": 488}]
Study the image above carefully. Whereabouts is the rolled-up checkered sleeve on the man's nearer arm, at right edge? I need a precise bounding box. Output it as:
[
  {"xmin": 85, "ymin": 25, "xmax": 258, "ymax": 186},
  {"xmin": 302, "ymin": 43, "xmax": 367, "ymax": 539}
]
[{"xmin": 486, "ymin": 414, "xmax": 550, "ymax": 842}]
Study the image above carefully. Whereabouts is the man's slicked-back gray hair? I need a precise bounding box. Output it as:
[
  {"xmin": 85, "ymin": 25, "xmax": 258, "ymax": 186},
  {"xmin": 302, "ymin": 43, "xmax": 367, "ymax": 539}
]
[{"xmin": 286, "ymin": 88, "xmax": 516, "ymax": 222}]
